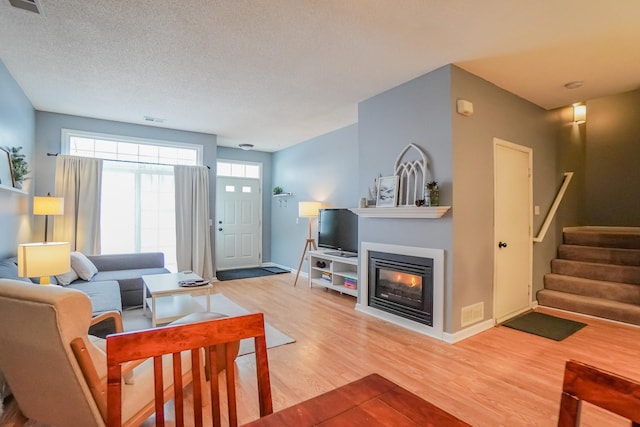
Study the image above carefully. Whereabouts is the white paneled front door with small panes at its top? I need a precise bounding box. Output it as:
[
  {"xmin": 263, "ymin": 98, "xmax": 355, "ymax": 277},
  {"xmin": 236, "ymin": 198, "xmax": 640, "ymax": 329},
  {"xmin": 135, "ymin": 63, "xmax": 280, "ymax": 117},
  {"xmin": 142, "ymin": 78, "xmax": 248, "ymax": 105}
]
[{"xmin": 215, "ymin": 176, "xmax": 262, "ymax": 270}]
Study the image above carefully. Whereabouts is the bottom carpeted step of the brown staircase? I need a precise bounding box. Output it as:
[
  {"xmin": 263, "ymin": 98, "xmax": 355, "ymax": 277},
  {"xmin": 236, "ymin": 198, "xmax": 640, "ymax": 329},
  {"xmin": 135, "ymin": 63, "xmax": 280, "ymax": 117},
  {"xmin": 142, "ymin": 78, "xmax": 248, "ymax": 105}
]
[{"xmin": 536, "ymin": 289, "xmax": 640, "ymax": 325}]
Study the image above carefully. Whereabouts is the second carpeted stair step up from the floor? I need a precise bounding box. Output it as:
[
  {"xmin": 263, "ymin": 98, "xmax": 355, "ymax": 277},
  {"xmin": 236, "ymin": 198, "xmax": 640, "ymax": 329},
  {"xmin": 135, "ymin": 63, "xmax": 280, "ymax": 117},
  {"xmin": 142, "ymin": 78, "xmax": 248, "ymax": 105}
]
[{"xmin": 544, "ymin": 274, "xmax": 640, "ymax": 305}]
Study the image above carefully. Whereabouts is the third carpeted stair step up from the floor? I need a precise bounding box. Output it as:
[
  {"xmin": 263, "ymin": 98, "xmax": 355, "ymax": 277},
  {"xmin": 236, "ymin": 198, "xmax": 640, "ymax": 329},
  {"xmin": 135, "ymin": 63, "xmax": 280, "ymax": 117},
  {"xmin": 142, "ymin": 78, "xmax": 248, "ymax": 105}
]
[{"xmin": 551, "ymin": 259, "xmax": 640, "ymax": 285}]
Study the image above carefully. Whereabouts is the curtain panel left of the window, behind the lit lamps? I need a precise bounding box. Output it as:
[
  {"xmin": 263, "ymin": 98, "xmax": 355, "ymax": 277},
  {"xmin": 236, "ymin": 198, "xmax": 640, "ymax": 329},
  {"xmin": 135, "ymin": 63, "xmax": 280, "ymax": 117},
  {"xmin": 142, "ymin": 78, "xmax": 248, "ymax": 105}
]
[{"xmin": 53, "ymin": 156, "xmax": 102, "ymax": 255}]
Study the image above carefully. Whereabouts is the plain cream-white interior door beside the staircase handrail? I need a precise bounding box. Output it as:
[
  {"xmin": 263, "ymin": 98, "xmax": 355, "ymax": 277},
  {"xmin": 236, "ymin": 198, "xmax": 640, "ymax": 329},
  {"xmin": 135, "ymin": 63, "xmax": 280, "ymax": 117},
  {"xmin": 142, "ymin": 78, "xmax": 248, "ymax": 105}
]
[{"xmin": 493, "ymin": 138, "xmax": 533, "ymax": 323}]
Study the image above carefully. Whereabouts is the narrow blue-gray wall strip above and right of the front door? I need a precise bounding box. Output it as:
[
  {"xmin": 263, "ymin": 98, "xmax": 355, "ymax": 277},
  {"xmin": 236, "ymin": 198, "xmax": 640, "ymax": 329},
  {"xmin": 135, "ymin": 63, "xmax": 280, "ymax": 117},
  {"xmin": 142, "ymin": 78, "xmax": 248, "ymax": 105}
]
[{"xmin": 218, "ymin": 147, "xmax": 273, "ymax": 263}]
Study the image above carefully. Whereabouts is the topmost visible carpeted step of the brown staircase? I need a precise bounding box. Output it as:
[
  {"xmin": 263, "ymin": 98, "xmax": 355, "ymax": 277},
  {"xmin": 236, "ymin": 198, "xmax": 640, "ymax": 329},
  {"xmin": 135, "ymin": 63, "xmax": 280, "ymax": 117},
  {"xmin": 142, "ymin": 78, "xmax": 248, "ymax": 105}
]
[{"xmin": 563, "ymin": 227, "xmax": 640, "ymax": 249}]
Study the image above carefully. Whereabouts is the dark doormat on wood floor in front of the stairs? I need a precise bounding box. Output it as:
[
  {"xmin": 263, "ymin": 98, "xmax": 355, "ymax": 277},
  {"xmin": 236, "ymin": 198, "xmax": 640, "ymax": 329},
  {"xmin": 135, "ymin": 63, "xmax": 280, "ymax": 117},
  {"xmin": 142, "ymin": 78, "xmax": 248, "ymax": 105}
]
[{"xmin": 502, "ymin": 311, "xmax": 587, "ymax": 341}]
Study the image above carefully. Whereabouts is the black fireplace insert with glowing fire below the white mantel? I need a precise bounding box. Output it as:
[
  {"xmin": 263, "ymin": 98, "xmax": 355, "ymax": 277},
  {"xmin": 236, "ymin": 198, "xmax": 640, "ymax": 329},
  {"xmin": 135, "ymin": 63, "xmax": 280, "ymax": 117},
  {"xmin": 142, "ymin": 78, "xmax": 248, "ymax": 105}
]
[{"xmin": 368, "ymin": 251, "xmax": 433, "ymax": 326}]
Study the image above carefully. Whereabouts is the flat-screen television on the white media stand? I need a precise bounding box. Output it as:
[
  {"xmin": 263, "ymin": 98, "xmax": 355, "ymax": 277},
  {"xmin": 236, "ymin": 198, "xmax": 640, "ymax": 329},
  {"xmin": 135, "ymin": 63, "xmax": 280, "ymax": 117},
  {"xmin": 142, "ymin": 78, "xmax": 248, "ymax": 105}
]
[{"xmin": 318, "ymin": 208, "xmax": 358, "ymax": 257}]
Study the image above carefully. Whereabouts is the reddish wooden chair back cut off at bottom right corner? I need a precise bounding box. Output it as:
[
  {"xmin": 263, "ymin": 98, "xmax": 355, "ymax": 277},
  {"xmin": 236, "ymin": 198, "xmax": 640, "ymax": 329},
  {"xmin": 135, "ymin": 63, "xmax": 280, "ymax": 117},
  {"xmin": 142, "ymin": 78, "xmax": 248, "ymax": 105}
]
[{"xmin": 558, "ymin": 360, "xmax": 640, "ymax": 427}]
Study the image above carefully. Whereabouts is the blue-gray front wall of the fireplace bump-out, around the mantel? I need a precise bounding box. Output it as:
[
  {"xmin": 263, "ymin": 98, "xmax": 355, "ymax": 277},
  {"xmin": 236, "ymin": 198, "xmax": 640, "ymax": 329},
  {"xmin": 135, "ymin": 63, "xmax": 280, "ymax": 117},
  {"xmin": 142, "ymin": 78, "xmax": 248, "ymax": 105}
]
[{"xmin": 358, "ymin": 66, "xmax": 453, "ymax": 324}]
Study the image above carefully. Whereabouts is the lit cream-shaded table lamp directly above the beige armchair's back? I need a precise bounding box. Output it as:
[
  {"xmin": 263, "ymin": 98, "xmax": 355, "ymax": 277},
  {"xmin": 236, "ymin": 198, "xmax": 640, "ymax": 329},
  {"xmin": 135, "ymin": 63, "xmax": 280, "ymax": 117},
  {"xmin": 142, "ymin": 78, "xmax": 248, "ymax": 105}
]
[{"xmin": 18, "ymin": 242, "xmax": 71, "ymax": 285}]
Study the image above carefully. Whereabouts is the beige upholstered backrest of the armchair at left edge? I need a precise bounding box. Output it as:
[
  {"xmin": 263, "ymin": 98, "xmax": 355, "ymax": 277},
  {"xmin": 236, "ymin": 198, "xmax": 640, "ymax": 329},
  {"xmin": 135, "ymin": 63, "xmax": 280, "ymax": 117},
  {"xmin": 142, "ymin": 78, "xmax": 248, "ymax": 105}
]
[{"xmin": 0, "ymin": 279, "xmax": 106, "ymax": 426}]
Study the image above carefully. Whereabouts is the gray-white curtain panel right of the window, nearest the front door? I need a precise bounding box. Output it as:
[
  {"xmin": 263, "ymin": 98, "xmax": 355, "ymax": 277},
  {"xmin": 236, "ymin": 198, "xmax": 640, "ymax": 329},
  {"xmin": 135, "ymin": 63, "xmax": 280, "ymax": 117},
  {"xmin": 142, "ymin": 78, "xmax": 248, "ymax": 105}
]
[{"xmin": 174, "ymin": 166, "xmax": 213, "ymax": 280}]
